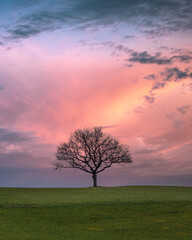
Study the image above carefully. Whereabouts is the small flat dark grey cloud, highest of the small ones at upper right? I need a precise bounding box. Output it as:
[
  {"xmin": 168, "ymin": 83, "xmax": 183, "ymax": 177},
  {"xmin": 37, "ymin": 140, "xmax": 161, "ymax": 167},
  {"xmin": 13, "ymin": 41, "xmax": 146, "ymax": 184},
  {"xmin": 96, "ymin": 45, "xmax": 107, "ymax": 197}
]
[{"xmin": 128, "ymin": 51, "xmax": 172, "ymax": 65}]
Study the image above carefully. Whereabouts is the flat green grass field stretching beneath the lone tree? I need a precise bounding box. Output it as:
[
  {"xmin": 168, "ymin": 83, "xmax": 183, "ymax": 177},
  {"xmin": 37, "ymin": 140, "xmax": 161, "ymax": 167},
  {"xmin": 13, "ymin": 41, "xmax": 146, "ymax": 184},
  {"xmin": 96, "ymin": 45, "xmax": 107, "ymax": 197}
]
[{"xmin": 0, "ymin": 186, "xmax": 192, "ymax": 240}]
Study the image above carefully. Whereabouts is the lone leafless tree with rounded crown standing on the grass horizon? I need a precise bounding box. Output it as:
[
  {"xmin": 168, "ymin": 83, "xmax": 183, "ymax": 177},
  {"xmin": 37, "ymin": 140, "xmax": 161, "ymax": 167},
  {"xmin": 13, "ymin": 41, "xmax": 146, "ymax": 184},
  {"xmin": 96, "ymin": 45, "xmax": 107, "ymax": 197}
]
[{"xmin": 54, "ymin": 127, "xmax": 132, "ymax": 187}]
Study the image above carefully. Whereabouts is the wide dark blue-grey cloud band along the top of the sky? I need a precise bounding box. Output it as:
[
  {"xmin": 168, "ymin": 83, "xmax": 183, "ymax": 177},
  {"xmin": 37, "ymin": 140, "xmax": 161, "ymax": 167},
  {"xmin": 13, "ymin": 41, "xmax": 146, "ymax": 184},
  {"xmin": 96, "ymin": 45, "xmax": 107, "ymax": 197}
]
[{"xmin": 1, "ymin": 0, "xmax": 192, "ymax": 39}]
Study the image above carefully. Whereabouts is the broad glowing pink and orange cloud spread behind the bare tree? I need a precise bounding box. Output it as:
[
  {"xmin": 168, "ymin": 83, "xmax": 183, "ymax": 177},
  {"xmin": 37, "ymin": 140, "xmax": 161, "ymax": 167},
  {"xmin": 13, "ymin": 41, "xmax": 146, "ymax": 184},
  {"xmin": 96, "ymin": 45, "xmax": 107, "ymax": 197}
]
[{"xmin": 0, "ymin": 41, "xmax": 192, "ymax": 186}]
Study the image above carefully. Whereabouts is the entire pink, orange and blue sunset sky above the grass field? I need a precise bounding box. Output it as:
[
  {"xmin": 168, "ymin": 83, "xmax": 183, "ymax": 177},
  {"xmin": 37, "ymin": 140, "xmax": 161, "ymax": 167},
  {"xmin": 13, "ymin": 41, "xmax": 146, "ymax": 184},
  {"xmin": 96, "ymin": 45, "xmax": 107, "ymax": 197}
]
[{"xmin": 0, "ymin": 0, "xmax": 192, "ymax": 187}]
